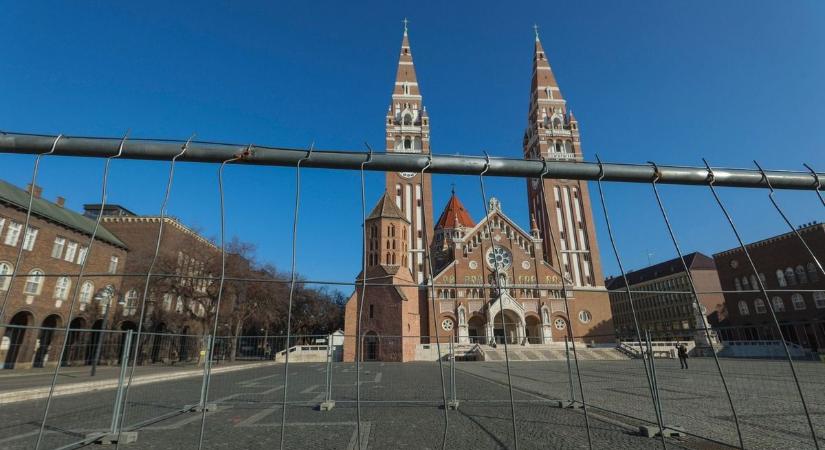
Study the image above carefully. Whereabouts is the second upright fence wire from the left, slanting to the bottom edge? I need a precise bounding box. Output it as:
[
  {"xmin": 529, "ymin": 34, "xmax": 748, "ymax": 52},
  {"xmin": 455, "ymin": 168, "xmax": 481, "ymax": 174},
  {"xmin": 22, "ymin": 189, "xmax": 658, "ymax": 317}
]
[{"xmin": 32, "ymin": 132, "xmax": 129, "ymax": 450}]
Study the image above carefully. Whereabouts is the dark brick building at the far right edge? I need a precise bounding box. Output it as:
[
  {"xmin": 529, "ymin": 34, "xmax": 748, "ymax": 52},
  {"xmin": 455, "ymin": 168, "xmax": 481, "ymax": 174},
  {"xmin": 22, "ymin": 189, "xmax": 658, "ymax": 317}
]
[{"xmin": 713, "ymin": 223, "xmax": 825, "ymax": 350}]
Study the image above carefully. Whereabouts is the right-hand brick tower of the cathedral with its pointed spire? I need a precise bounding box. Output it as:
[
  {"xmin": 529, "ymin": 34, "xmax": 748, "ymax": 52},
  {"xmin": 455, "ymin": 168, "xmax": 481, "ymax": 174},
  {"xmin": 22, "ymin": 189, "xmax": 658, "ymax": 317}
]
[{"xmin": 524, "ymin": 28, "xmax": 604, "ymax": 287}]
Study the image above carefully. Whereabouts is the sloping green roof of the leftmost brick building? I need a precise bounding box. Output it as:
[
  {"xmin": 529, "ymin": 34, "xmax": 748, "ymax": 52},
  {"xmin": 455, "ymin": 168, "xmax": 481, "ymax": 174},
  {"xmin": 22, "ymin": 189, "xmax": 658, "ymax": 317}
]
[{"xmin": 0, "ymin": 180, "xmax": 127, "ymax": 248}]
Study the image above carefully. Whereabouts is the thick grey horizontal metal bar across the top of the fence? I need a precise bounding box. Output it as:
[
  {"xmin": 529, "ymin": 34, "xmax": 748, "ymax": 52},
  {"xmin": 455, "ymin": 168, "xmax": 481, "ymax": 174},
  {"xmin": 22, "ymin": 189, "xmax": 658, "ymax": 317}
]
[{"xmin": 0, "ymin": 132, "xmax": 825, "ymax": 190}]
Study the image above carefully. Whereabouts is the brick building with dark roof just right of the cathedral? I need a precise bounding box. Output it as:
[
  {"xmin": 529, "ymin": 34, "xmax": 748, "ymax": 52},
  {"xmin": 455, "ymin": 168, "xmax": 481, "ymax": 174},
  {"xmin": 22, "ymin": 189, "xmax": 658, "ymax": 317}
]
[{"xmin": 605, "ymin": 252, "xmax": 725, "ymax": 345}]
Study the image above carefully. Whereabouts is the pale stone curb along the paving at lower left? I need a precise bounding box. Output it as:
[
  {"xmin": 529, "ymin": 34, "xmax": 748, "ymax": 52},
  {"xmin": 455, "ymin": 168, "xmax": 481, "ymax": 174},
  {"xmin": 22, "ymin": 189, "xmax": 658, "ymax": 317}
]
[{"xmin": 0, "ymin": 362, "xmax": 277, "ymax": 405}]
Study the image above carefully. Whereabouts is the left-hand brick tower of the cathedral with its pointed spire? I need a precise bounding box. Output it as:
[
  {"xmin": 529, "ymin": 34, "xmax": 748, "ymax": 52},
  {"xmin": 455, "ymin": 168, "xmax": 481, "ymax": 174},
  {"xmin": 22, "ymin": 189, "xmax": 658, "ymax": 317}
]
[{"xmin": 385, "ymin": 19, "xmax": 433, "ymax": 283}]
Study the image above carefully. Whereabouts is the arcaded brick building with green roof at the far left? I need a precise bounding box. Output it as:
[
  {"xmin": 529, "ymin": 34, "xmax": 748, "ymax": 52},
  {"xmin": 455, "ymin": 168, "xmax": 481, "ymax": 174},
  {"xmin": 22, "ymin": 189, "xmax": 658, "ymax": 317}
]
[{"xmin": 0, "ymin": 181, "xmax": 128, "ymax": 368}]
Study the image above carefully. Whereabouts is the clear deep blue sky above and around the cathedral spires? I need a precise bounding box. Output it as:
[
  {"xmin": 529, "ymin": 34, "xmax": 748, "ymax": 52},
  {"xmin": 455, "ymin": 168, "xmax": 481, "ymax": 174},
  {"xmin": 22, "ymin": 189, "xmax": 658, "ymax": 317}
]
[{"xmin": 0, "ymin": 0, "xmax": 825, "ymax": 291}]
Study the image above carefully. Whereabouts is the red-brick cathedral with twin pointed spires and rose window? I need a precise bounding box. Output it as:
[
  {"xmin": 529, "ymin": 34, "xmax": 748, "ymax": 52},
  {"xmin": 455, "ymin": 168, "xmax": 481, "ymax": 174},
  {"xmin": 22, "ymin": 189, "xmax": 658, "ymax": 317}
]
[{"xmin": 344, "ymin": 26, "xmax": 614, "ymax": 361}]
